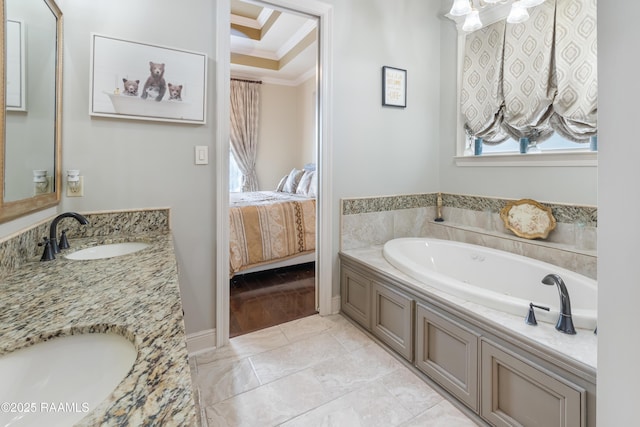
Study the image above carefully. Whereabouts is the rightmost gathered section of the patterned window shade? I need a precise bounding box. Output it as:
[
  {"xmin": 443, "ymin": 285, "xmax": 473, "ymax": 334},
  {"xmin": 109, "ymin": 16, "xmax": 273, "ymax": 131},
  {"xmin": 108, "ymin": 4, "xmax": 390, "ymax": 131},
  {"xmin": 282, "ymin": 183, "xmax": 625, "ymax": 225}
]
[{"xmin": 552, "ymin": 0, "xmax": 598, "ymax": 142}]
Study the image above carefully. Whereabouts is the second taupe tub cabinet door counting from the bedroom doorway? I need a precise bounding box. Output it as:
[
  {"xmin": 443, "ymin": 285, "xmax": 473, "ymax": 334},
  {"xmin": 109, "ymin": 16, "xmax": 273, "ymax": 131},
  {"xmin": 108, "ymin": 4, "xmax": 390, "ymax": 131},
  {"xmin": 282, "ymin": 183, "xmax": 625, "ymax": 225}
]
[{"xmin": 371, "ymin": 282, "xmax": 413, "ymax": 362}]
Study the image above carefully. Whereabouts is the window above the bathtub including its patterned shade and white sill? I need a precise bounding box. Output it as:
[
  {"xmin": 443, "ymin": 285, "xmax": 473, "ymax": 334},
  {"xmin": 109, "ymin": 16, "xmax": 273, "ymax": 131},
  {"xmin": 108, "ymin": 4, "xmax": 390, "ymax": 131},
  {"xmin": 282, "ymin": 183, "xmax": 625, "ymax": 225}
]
[{"xmin": 456, "ymin": 0, "xmax": 597, "ymax": 166}]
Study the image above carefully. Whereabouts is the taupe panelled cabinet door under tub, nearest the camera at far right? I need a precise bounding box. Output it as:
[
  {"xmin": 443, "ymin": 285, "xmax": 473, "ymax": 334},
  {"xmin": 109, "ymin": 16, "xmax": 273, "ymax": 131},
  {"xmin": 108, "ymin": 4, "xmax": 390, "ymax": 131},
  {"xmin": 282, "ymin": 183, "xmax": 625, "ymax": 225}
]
[{"xmin": 480, "ymin": 340, "xmax": 586, "ymax": 427}]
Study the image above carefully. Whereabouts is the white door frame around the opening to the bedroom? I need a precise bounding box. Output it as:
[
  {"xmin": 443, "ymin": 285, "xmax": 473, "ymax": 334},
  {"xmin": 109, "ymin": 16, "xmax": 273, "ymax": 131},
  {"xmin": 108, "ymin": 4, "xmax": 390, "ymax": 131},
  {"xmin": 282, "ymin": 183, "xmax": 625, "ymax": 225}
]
[{"xmin": 215, "ymin": 0, "xmax": 335, "ymax": 347}]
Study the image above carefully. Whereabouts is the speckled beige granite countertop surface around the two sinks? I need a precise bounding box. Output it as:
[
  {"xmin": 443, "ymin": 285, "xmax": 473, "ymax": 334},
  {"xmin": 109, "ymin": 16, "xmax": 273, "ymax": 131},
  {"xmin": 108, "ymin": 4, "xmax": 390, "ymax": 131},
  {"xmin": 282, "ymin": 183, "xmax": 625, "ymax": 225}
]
[{"xmin": 0, "ymin": 232, "xmax": 197, "ymax": 426}]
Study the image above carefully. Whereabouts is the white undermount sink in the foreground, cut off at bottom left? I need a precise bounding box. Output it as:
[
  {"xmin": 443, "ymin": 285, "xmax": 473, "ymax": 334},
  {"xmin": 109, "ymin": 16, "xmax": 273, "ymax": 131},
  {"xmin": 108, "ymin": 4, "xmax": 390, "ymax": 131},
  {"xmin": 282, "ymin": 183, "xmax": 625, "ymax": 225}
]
[{"xmin": 0, "ymin": 333, "xmax": 137, "ymax": 427}]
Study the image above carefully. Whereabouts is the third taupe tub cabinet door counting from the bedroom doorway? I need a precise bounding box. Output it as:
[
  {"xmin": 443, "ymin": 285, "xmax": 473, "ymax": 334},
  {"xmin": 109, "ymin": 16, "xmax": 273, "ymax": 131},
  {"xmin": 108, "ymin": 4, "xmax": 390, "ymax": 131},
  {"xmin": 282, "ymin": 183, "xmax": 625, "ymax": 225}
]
[{"xmin": 416, "ymin": 304, "xmax": 479, "ymax": 412}]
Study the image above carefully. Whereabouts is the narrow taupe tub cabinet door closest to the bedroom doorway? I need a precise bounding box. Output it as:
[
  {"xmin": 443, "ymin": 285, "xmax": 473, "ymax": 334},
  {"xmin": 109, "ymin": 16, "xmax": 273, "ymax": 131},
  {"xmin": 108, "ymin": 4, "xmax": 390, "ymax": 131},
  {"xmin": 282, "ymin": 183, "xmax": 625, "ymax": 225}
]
[{"xmin": 340, "ymin": 266, "xmax": 371, "ymax": 330}]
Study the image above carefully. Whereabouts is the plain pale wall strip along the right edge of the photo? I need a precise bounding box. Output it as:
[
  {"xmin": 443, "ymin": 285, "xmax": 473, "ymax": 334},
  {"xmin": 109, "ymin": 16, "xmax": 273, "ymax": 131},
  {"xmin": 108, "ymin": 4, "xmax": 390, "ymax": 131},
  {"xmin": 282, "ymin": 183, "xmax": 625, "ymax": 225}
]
[{"xmin": 598, "ymin": 1, "xmax": 640, "ymax": 426}]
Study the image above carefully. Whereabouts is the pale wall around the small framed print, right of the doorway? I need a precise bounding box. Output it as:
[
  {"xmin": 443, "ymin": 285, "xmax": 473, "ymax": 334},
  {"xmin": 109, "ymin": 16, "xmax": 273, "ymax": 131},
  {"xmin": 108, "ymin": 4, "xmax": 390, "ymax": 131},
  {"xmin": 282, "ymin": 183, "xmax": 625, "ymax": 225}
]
[{"xmin": 327, "ymin": 0, "xmax": 440, "ymax": 295}]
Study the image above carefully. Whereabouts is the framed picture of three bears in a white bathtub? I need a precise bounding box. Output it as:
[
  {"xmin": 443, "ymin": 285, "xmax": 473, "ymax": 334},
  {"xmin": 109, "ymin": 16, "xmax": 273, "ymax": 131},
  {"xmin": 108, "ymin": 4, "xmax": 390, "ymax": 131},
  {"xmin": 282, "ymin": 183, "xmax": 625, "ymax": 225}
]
[{"xmin": 89, "ymin": 34, "xmax": 207, "ymax": 124}]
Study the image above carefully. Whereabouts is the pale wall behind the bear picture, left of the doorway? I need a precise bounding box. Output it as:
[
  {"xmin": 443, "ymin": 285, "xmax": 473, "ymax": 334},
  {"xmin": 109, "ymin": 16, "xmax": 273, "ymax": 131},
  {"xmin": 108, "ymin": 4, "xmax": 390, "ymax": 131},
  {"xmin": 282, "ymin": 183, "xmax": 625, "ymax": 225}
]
[{"xmin": 58, "ymin": 0, "xmax": 216, "ymax": 332}]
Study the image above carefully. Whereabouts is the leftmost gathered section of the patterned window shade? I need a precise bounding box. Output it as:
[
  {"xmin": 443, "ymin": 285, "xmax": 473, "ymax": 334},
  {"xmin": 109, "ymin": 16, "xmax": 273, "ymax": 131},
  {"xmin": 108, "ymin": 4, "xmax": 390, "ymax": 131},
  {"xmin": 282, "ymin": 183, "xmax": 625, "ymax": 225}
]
[{"xmin": 460, "ymin": 21, "xmax": 508, "ymax": 143}]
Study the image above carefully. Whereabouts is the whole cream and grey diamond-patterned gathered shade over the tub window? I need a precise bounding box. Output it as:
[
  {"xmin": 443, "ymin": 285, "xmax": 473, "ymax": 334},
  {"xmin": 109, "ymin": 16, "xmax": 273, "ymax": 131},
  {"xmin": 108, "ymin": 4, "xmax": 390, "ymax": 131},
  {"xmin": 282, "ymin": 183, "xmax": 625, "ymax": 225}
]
[{"xmin": 461, "ymin": 0, "xmax": 598, "ymax": 144}]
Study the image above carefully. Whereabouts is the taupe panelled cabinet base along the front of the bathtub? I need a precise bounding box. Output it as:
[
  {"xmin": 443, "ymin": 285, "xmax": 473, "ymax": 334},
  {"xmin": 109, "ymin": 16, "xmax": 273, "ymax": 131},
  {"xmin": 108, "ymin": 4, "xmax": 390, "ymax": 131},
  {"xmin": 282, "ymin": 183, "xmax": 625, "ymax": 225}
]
[{"xmin": 341, "ymin": 257, "xmax": 596, "ymax": 427}]
